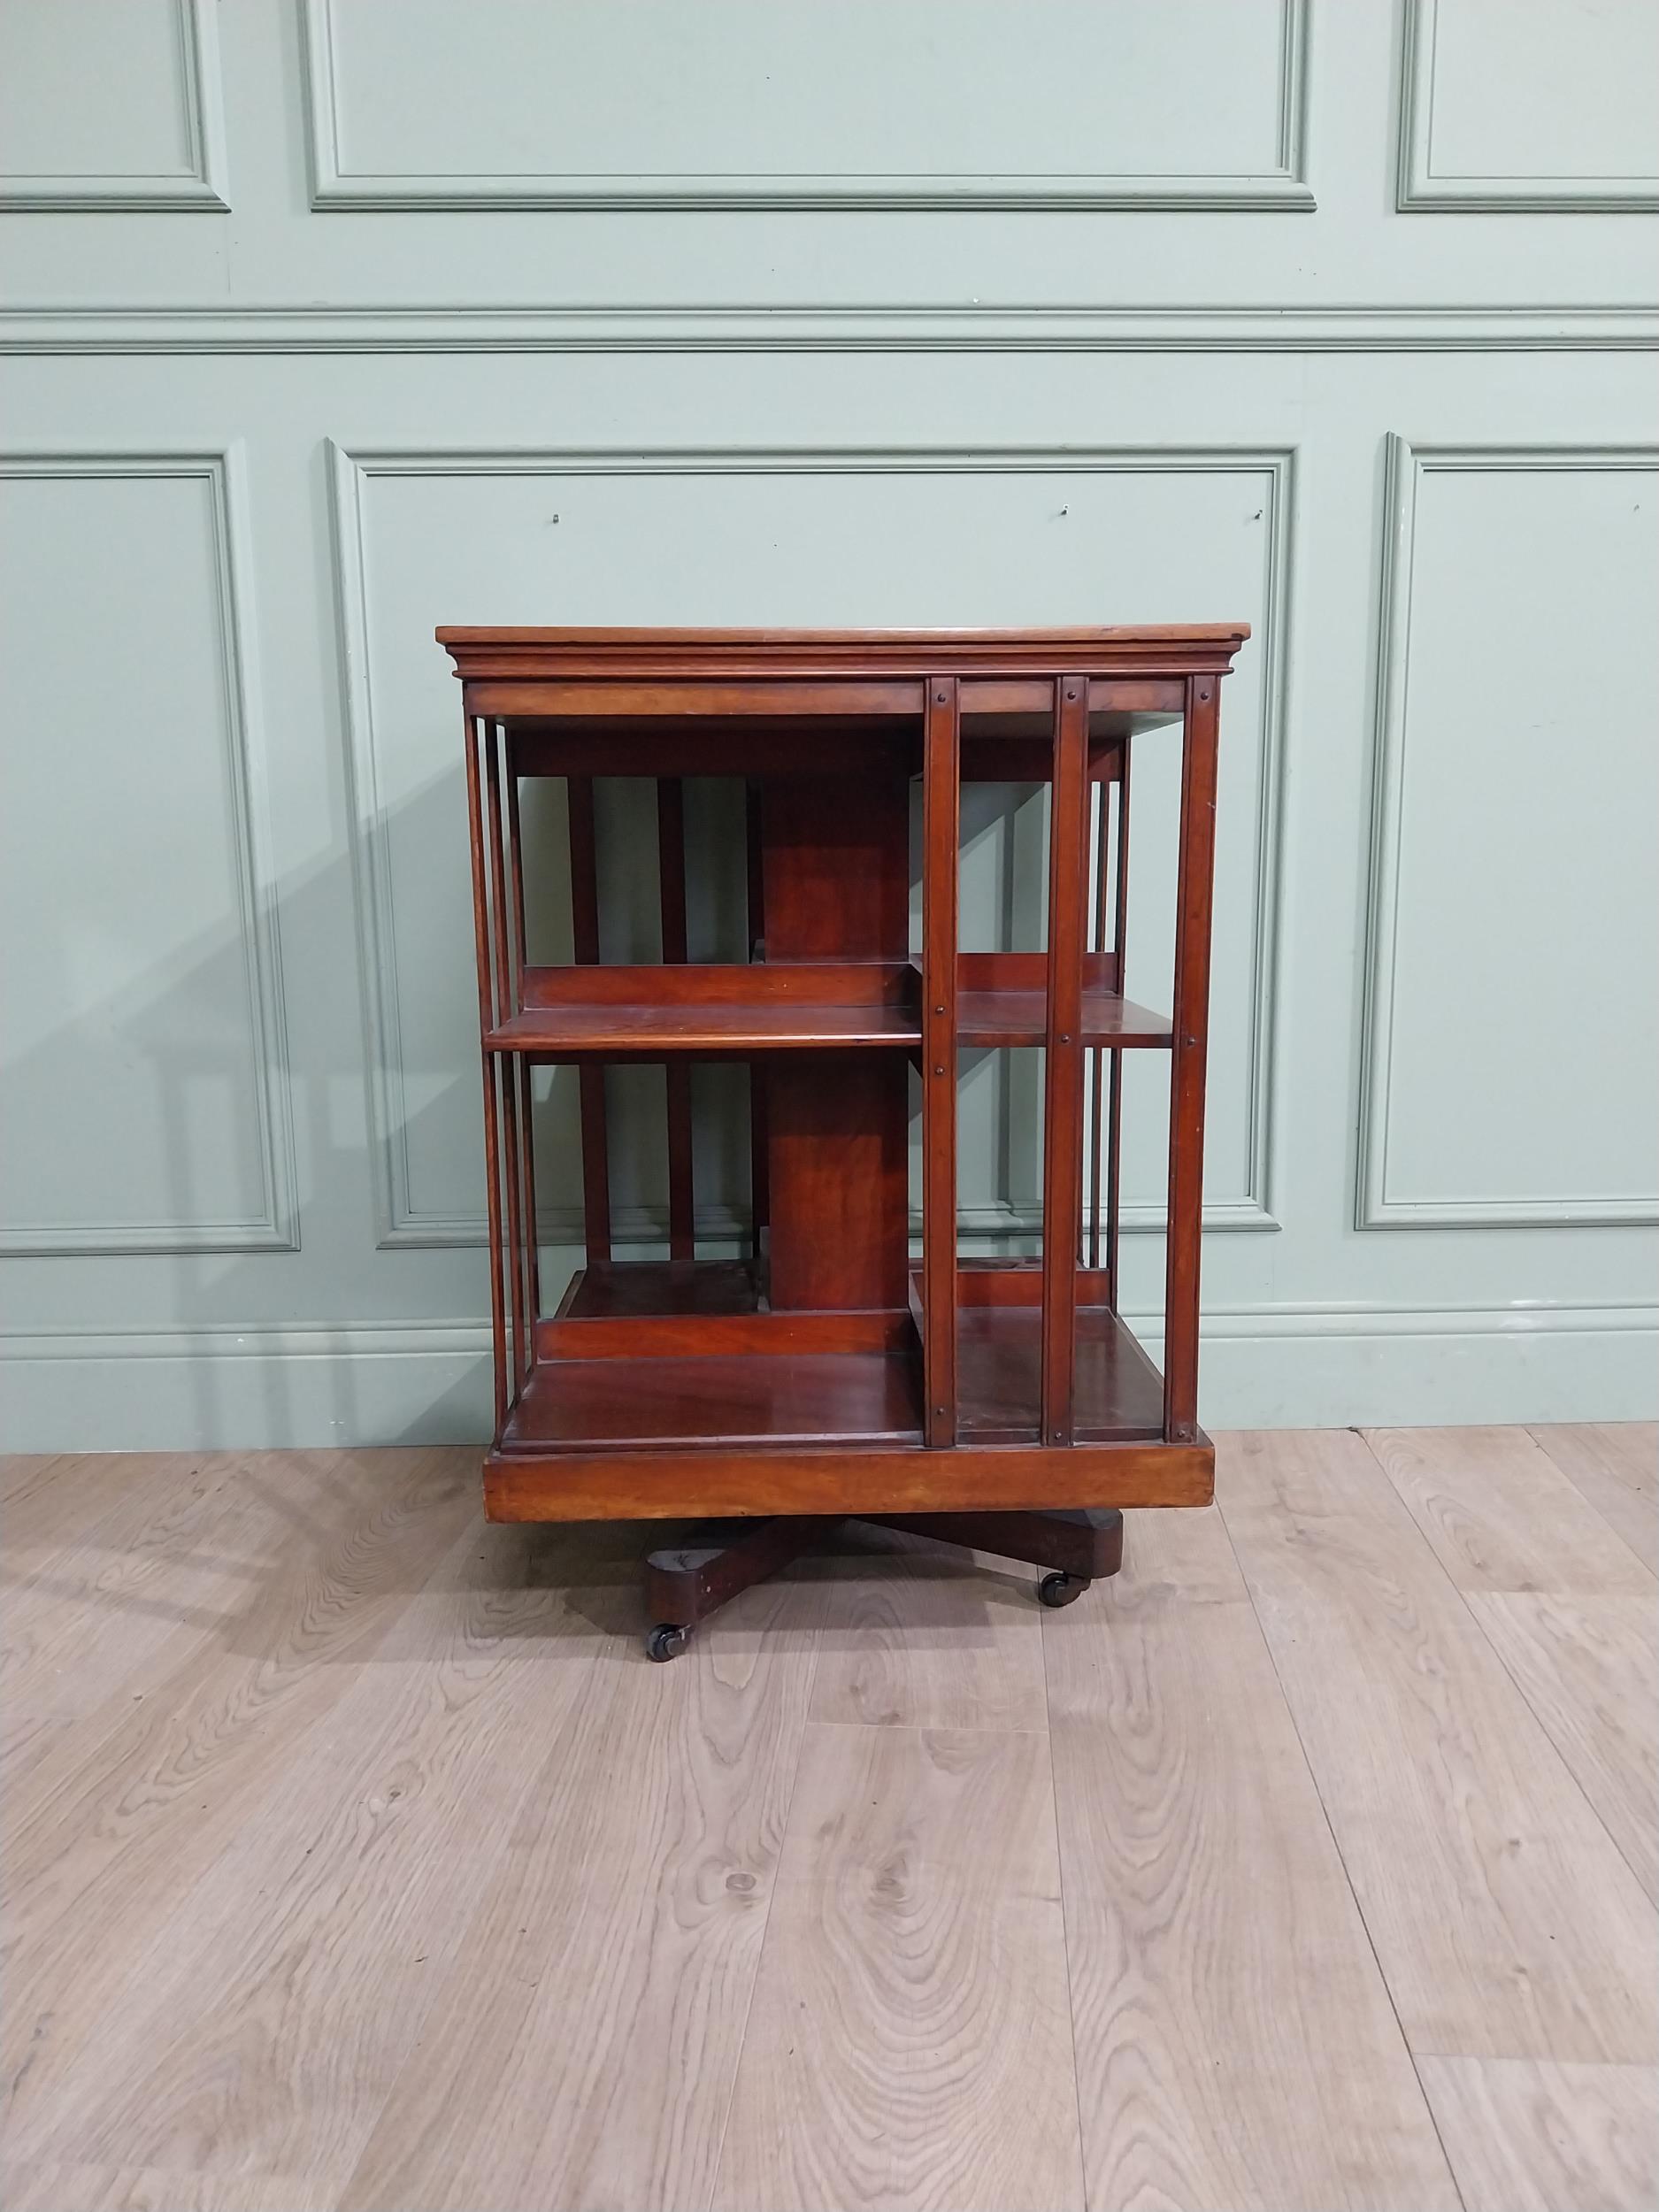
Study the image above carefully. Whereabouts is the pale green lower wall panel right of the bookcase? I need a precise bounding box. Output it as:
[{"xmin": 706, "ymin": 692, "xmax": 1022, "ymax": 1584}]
[{"xmin": 1358, "ymin": 441, "xmax": 1659, "ymax": 1228}]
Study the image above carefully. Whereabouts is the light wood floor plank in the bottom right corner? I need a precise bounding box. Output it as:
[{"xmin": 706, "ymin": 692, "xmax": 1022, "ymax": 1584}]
[{"xmin": 1423, "ymin": 2060, "xmax": 1659, "ymax": 2212}]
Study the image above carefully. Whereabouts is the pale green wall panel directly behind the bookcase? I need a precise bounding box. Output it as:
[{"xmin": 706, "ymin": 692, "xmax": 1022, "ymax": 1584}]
[{"xmin": 336, "ymin": 451, "xmax": 1290, "ymax": 1243}]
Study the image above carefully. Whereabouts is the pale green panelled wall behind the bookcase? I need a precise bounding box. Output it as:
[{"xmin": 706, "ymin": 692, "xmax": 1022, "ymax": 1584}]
[{"xmin": 0, "ymin": 0, "xmax": 1659, "ymax": 1449}]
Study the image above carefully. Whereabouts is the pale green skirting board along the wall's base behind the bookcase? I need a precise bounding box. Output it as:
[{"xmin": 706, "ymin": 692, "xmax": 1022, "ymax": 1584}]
[{"xmin": 0, "ymin": 1305, "xmax": 1659, "ymax": 1451}]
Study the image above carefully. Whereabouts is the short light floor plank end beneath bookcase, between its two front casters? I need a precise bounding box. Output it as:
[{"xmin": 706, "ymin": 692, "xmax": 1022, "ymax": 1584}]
[{"xmin": 812, "ymin": 1529, "xmax": 1048, "ymax": 1730}]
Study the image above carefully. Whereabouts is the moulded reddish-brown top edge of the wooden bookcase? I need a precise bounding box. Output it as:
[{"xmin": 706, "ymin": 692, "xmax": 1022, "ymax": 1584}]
[{"xmin": 438, "ymin": 622, "xmax": 1250, "ymax": 686}]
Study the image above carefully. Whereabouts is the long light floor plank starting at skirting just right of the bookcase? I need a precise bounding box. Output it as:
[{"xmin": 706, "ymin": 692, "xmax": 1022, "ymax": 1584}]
[{"xmin": 1217, "ymin": 1432, "xmax": 1655, "ymax": 2064}]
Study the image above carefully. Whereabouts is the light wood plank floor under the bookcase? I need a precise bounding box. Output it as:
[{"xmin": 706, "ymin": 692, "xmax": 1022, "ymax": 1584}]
[{"xmin": 0, "ymin": 1429, "xmax": 1659, "ymax": 2212}]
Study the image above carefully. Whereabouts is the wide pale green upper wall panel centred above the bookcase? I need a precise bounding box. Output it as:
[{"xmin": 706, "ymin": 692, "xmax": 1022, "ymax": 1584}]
[{"xmin": 308, "ymin": 0, "xmax": 1312, "ymax": 208}]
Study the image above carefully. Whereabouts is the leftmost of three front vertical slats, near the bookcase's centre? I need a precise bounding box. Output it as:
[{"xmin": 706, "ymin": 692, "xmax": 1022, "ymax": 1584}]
[{"xmin": 923, "ymin": 677, "xmax": 963, "ymax": 1447}]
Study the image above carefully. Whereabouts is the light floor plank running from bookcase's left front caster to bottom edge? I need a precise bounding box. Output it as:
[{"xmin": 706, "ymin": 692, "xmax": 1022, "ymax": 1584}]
[{"xmin": 341, "ymin": 1566, "xmax": 817, "ymax": 2212}]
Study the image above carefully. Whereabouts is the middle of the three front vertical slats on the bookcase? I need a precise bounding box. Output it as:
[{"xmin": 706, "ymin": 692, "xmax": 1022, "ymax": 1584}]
[{"xmin": 1042, "ymin": 677, "xmax": 1088, "ymax": 1445}]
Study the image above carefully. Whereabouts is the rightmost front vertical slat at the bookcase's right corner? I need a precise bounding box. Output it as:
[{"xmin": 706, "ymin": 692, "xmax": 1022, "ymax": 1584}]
[{"xmin": 1164, "ymin": 677, "xmax": 1221, "ymax": 1445}]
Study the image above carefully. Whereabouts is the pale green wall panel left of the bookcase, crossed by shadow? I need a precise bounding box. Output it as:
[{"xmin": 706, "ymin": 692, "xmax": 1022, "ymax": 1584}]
[{"xmin": 0, "ymin": 454, "xmax": 296, "ymax": 1252}]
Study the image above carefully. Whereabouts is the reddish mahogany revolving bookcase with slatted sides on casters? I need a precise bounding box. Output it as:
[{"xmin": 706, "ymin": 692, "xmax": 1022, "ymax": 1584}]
[{"xmin": 438, "ymin": 624, "xmax": 1250, "ymax": 1659}]
